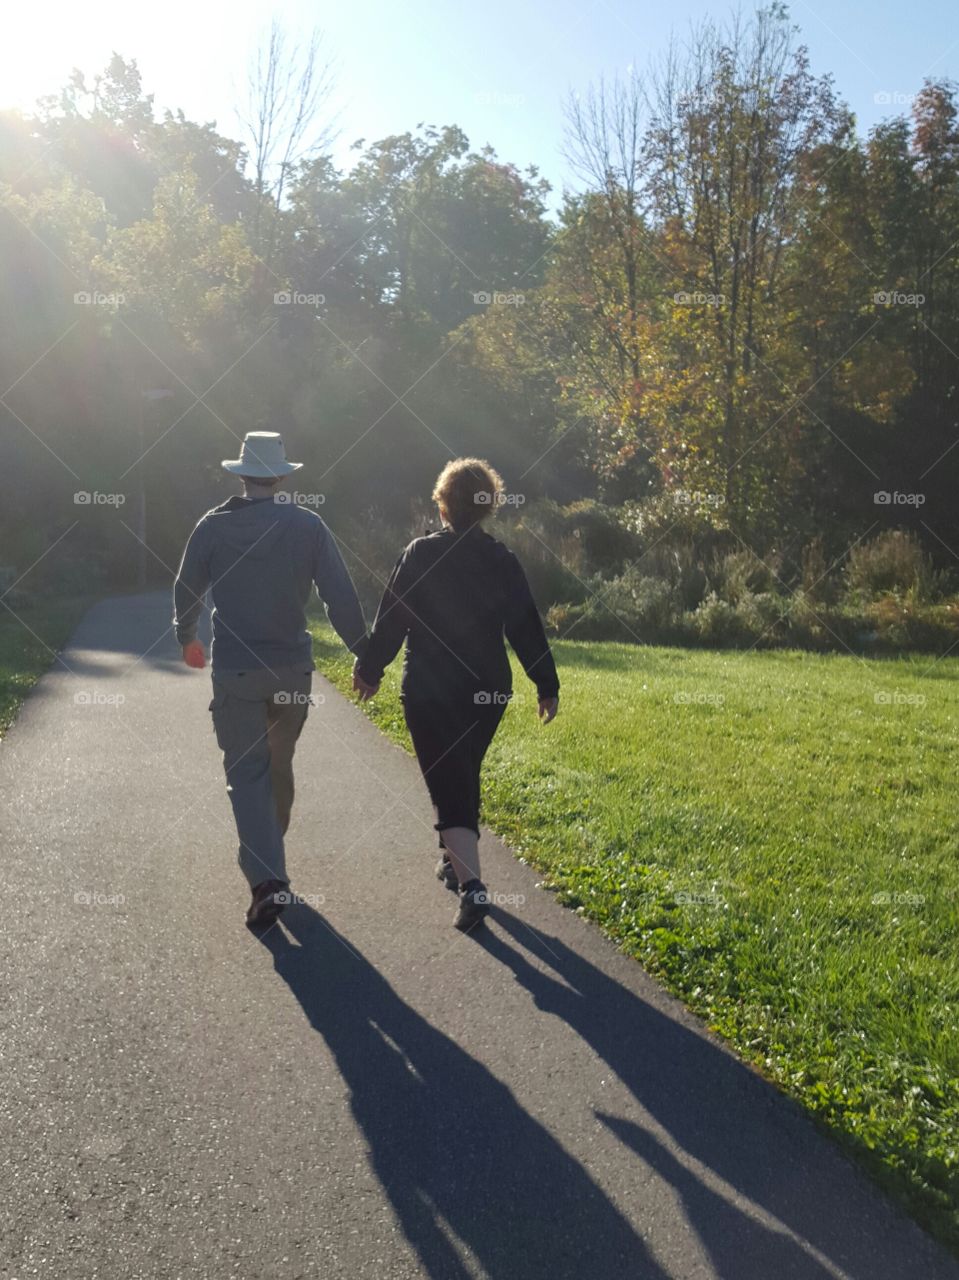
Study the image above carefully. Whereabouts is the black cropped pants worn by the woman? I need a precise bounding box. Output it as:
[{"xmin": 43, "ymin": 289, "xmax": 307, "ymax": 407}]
[{"xmin": 403, "ymin": 694, "xmax": 507, "ymax": 845}]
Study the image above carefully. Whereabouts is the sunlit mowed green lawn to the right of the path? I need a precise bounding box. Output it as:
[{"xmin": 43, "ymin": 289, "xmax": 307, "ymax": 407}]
[{"xmin": 316, "ymin": 625, "xmax": 959, "ymax": 1247}]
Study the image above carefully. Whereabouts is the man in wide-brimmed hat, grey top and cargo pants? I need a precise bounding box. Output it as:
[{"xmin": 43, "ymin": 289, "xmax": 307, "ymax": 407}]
[{"xmin": 173, "ymin": 431, "xmax": 366, "ymax": 927}]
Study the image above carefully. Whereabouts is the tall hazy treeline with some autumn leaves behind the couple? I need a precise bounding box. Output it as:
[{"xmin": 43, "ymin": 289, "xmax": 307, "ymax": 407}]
[{"xmin": 0, "ymin": 6, "xmax": 959, "ymax": 645}]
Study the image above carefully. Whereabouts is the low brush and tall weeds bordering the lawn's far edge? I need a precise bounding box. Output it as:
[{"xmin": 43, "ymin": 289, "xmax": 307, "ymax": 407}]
[{"xmin": 530, "ymin": 517, "xmax": 959, "ymax": 653}]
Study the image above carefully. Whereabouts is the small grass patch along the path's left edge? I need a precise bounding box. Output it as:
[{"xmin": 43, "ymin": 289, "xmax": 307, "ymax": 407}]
[{"xmin": 0, "ymin": 596, "xmax": 90, "ymax": 737}]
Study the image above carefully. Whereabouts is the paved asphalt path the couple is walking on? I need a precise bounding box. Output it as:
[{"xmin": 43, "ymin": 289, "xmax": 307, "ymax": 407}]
[{"xmin": 0, "ymin": 595, "xmax": 959, "ymax": 1280}]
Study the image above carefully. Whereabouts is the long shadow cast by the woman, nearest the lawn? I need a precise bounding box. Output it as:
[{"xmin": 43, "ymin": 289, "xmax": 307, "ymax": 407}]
[{"xmin": 476, "ymin": 908, "xmax": 926, "ymax": 1280}]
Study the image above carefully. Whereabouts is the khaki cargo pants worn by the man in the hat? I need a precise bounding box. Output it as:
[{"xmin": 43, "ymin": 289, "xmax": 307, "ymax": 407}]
[{"xmin": 210, "ymin": 663, "xmax": 312, "ymax": 887}]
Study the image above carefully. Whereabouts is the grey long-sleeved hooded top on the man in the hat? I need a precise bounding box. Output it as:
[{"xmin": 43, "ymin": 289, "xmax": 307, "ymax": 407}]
[{"xmin": 173, "ymin": 498, "xmax": 366, "ymax": 671}]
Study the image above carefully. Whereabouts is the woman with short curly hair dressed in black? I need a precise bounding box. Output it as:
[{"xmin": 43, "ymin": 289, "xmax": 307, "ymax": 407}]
[{"xmin": 353, "ymin": 458, "xmax": 560, "ymax": 931}]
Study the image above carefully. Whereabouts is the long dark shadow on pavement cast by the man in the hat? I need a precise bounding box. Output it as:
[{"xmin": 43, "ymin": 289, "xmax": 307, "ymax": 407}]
[{"xmin": 261, "ymin": 902, "xmax": 668, "ymax": 1280}]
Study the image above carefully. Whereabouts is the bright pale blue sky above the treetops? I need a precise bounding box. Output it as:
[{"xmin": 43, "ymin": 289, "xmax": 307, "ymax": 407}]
[{"xmin": 0, "ymin": 0, "xmax": 959, "ymax": 212}]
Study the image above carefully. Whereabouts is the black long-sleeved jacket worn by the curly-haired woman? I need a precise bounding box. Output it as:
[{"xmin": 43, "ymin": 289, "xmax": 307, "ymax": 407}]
[{"xmin": 360, "ymin": 525, "xmax": 560, "ymax": 701}]
